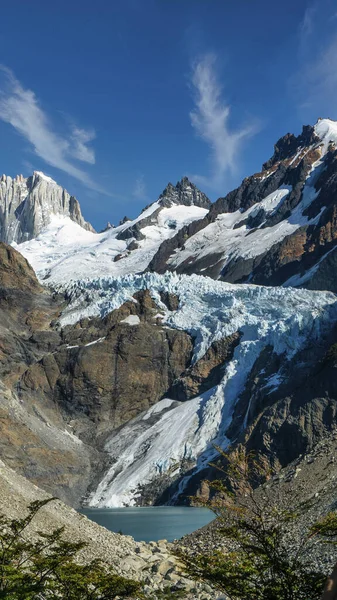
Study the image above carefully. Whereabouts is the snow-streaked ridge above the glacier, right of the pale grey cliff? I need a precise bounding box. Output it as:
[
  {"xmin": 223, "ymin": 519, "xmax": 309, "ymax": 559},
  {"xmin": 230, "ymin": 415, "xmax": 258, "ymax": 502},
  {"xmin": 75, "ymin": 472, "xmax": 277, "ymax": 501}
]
[{"xmin": 5, "ymin": 119, "xmax": 337, "ymax": 291}]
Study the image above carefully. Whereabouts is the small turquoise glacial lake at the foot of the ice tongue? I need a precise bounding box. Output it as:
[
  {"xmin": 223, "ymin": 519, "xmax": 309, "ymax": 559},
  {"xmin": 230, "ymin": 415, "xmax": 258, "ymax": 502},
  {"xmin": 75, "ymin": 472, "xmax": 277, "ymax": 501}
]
[{"xmin": 80, "ymin": 506, "xmax": 214, "ymax": 542}]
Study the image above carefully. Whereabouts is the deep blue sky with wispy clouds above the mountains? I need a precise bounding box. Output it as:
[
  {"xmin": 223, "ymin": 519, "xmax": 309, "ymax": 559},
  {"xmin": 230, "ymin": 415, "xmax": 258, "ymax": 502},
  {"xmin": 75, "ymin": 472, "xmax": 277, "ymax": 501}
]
[{"xmin": 0, "ymin": 0, "xmax": 337, "ymax": 229}]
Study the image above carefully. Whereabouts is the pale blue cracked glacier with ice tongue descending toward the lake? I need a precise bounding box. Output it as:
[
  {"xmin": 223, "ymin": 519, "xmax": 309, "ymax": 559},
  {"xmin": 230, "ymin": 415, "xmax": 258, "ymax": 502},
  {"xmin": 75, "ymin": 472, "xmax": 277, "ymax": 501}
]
[{"xmin": 53, "ymin": 273, "xmax": 337, "ymax": 507}]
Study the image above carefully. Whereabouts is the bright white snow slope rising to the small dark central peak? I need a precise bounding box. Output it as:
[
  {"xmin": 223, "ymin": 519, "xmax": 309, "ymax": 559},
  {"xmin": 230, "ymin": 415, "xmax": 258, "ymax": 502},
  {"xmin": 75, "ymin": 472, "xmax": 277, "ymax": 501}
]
[{"xmin": 18, "ymin": 178, "xmax": 211, "ymax": 283}]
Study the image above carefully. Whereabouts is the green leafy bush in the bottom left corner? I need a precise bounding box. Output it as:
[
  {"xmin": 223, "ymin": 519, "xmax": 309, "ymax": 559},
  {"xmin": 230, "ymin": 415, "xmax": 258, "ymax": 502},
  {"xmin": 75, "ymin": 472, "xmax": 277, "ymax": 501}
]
[{"xmin": 0, "ymin": 499, "xmax": 140, "ymax": 600}]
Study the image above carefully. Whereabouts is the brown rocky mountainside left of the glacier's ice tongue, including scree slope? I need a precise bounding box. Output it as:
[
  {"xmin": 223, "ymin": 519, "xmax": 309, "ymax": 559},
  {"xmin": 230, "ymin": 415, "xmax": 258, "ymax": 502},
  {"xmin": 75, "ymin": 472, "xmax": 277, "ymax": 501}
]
[{"xmin": 0, "ymin": 244, "xmax": 197, "ymax": 505}]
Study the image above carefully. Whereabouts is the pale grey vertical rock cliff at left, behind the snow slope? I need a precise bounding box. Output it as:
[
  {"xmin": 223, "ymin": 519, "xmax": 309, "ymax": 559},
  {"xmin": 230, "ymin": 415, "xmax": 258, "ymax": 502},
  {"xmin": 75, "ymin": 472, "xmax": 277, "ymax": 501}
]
[{"xmin": 0, "ymin": 171, "xmax": 93, "ymax": 243}]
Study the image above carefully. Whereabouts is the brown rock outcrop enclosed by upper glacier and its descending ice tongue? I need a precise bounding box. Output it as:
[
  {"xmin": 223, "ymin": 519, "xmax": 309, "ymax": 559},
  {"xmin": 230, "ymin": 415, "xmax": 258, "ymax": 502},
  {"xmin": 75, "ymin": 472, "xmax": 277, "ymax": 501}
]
[{"xmin": 18, "ymin": 292, "xmax": 193, "ymax": 441}]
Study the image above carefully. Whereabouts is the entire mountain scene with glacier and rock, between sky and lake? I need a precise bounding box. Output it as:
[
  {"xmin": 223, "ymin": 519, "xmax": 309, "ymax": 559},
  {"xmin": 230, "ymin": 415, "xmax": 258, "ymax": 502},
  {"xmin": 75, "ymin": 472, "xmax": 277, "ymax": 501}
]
[{"xmin": 0, "ymin": 120, "xmax": 337, "ymax": 506}]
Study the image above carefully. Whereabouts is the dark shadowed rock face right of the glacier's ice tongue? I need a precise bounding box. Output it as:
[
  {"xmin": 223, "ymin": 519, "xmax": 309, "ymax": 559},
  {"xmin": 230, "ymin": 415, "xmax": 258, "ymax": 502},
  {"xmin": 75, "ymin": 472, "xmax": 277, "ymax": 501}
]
[{"xmin": 172, "ymin": 328, "xmax": 337, "ymax": 502}]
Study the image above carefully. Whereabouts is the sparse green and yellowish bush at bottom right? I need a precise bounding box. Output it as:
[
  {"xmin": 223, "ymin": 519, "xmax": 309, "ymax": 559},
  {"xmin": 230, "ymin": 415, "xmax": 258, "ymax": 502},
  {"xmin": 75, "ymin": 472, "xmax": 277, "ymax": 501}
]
[{"xmin": 180, "ymin": 449, "xmax": 337, "ymax": 600}]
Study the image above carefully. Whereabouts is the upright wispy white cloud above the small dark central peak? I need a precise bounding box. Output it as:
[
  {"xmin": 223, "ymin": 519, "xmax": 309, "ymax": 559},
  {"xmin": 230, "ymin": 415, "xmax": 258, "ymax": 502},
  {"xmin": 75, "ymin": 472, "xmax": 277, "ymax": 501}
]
[{"xmin": 190, "ymin": 54, "xmax": 258, "ymax": 188}]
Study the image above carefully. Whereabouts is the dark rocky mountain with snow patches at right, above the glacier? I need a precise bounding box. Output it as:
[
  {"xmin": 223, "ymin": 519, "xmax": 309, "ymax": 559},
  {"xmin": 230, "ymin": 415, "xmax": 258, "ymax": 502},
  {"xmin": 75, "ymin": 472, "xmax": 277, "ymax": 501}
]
[{"xmin": 150, "ymin": 119, "xmax": 337, "ymax": 291}]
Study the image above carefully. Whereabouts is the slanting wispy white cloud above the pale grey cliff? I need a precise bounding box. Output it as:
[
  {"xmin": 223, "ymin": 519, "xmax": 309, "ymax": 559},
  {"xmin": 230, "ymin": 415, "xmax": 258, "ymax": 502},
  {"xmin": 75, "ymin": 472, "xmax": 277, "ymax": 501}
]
[{"xmin": 0, "ymin": 65, "xmax": 107, "ymax": 194}]
